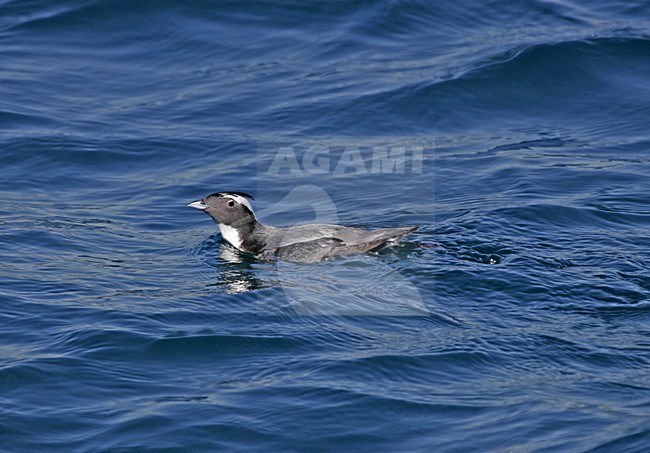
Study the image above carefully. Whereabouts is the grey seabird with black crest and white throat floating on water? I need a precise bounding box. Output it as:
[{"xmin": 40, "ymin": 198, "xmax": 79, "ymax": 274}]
[{"xmin": 189, "ymin": 192, "xmax": 418, "ymax": 263}]
